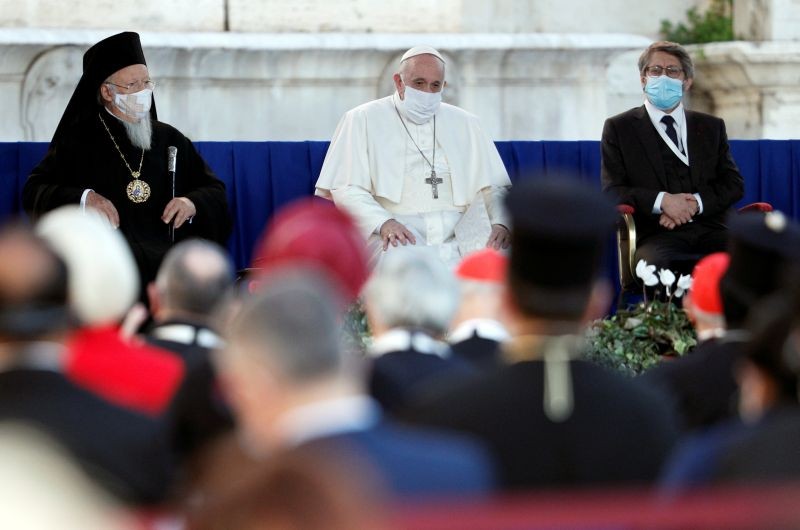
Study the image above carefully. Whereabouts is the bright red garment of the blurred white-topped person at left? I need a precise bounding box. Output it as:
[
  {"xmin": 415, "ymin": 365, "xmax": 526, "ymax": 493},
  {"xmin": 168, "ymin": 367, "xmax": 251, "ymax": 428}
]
[{"xmin": 64, "ymin": 326, "xmax": 185, "ymax": 416}]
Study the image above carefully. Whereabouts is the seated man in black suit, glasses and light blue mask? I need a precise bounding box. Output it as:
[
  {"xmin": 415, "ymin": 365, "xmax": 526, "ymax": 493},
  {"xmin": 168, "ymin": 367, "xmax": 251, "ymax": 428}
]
[{"xmin": 601, "ymin": 41, "xmax": 744, "ymax": 272}]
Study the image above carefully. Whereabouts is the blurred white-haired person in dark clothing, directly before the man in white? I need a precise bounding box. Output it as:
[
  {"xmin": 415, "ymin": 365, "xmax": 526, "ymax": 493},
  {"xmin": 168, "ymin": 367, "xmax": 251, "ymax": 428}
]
[{"xmin": 364, "ymin": 247, "xmax": 475, "ymax": 412}]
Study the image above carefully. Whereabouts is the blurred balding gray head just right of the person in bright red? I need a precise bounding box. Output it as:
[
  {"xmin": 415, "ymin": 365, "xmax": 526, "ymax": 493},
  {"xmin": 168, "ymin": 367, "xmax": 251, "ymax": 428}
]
[{"xmin": 156, "ymin": 239, "xmax": 234, "ymax": 317}]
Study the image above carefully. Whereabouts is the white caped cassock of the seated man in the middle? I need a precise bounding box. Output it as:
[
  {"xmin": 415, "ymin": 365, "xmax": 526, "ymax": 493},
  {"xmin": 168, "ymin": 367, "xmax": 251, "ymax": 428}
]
[{"xmin": 316, "ymin": 92, "xmax": 511, "ymax": 264}]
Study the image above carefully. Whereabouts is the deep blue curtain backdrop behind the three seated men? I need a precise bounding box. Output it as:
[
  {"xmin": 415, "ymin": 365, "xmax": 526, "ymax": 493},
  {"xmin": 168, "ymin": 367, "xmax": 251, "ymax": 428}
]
[{"xmin": 0, "ymin": 140, "xmax": 800, "ymax": 274}]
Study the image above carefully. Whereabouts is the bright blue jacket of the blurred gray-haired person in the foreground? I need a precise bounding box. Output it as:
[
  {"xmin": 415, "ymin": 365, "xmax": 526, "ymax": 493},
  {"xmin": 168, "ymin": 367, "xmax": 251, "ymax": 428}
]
[{"xmin": 304, "ymin": 421, "xmax": 495, "ymax": 500}]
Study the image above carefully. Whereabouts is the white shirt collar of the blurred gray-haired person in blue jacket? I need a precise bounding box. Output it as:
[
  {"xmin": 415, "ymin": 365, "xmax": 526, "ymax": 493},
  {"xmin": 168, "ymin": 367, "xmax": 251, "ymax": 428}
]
[{"xmin": 274, "ymin": 395, "xmax": 381, "ymax": 447}]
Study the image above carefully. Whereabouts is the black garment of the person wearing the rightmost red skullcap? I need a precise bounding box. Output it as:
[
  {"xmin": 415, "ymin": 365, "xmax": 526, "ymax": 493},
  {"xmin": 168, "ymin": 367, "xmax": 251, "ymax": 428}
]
[{"xmin": 641, "ymin": 340, "xmax": 742, "ymax": 430}]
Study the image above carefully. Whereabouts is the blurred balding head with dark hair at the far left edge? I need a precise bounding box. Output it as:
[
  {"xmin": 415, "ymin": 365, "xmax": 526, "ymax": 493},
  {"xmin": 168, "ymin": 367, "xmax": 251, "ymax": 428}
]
[{"xmin": 0, "ymin": 226, "xmax": 68, "ymax": 340}]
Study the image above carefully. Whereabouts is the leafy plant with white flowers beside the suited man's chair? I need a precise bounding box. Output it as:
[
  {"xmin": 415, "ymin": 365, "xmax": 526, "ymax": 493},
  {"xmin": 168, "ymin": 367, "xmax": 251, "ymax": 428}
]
[{"xmin": 586, "ymin": 260, "xmax": 697, "ymax": 376}]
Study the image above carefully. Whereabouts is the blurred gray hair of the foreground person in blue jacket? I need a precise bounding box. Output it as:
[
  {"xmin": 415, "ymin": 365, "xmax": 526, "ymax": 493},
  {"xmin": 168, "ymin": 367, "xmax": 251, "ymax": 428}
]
[{"xmin": 230, "ymin": 269, "xmax": 344, "ymax": 382}]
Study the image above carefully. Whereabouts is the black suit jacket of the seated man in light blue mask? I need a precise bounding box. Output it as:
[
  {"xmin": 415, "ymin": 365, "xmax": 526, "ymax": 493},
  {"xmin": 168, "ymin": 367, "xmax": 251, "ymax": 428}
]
[{"xmin": 600, "ymin": 105, "xmax": 744, "ymax": 237}]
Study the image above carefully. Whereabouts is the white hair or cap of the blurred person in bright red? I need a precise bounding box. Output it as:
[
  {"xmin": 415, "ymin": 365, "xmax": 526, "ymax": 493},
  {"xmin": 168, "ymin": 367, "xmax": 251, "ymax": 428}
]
[{"xmin": 36, "ymin": 206, "xmax": 139, "ymax": 326}]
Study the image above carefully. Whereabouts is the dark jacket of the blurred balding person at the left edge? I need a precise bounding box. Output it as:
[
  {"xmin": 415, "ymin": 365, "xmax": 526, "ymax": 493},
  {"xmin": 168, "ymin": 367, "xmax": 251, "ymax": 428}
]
[{"xmin": 0, "ymin": 368, "xmax": 172, "ymax": 504}]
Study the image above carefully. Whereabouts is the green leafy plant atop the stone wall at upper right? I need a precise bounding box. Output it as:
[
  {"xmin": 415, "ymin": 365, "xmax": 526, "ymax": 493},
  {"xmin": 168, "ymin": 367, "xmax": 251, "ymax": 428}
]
[{"xmin": 660, "ymin": 0, "xmax": 734, "ymax": 44}]
